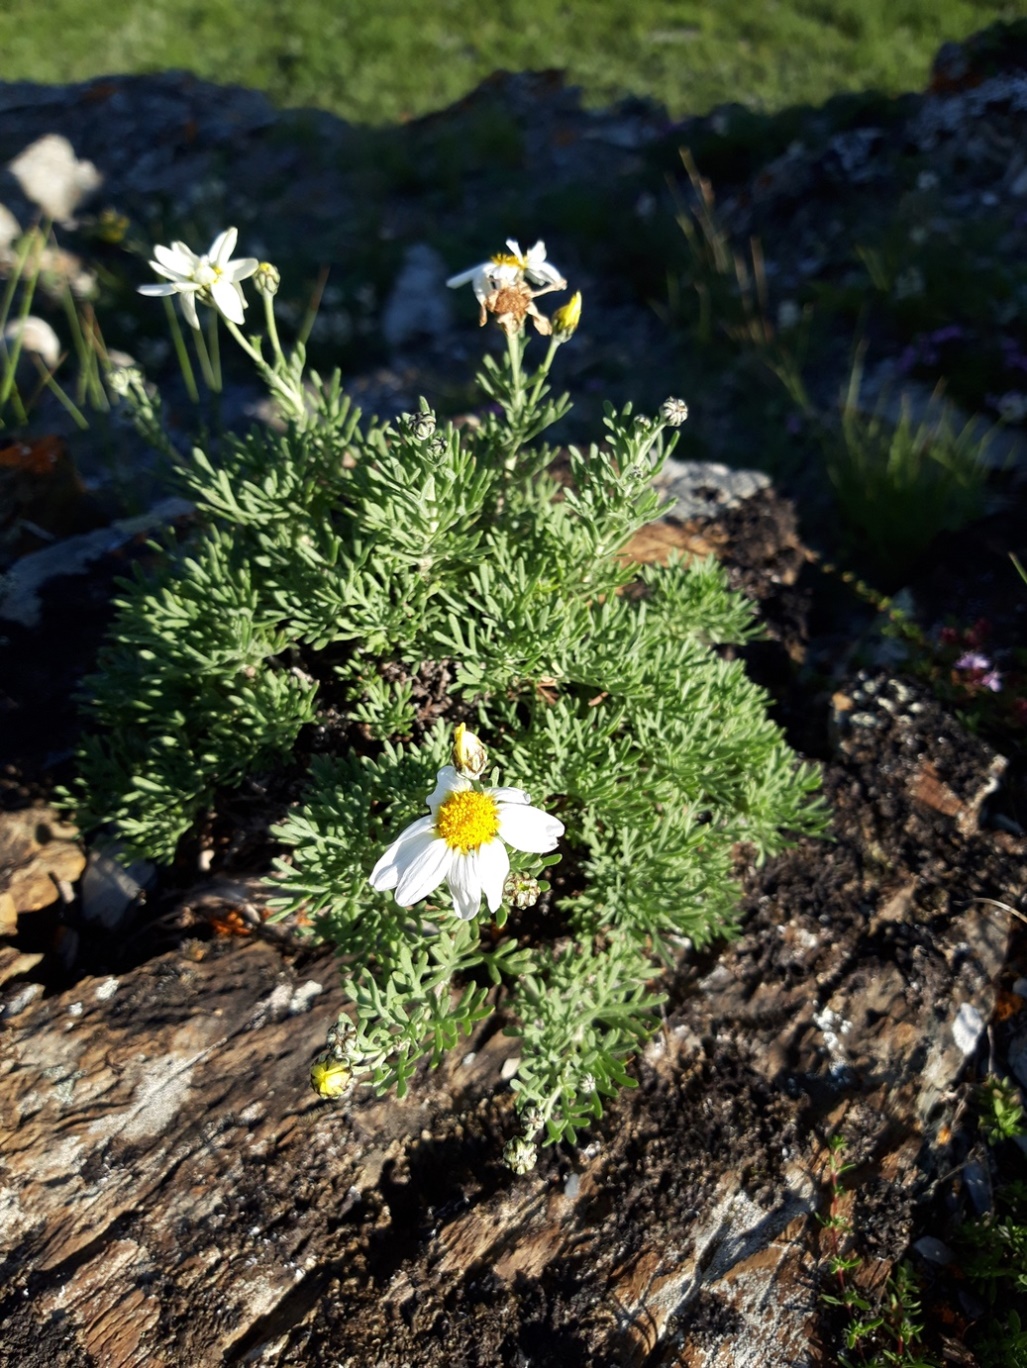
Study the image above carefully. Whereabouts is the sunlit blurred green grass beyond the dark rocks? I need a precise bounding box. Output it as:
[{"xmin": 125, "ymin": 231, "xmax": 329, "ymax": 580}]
[{"xmin": 0, "ymin": 0, "xmax": 1027, "ymax": 123}]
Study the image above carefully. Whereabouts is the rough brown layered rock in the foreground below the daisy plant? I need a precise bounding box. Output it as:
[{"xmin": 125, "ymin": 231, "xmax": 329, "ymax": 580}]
[{"xmin": 0, "ymin": 656, "xmax": 1023, "ymax": 1368}]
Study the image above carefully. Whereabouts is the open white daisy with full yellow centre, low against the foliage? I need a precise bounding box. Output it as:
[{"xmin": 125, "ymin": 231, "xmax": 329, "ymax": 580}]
[{"xmin": 371, "ymin": 765, "xmax": 563, "ymax": 921}]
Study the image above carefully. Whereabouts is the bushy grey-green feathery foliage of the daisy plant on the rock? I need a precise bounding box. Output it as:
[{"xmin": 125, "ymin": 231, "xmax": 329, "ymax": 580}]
[{"xmin": 78, "ymin": 266, "xmax": 826, "ymax": 1167}]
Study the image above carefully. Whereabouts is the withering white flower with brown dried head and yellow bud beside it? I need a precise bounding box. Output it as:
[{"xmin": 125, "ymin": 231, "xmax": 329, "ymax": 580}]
[{"xmin": 446, "ymin": 238, "xmax": 581, "ymax": 342}]
